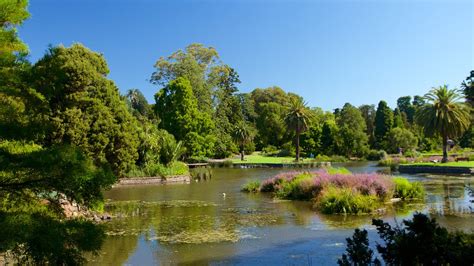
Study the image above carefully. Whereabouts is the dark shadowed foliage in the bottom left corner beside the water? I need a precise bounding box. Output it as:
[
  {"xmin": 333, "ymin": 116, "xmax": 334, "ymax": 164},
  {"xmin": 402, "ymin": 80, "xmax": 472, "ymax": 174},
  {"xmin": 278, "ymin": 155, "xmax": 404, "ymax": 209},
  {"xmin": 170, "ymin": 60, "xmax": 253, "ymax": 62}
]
[{"xmin": 0, "ymin": 210, "xmax": 105, "ymax": 265}]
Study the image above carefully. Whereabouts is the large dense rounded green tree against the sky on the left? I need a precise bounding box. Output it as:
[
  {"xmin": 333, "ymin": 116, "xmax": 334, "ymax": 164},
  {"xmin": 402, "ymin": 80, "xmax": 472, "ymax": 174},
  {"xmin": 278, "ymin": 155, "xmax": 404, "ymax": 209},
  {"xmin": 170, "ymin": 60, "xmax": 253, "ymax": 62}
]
[{"xmin": 31, "ymin": 44, "xmax": 138, "ymax": 176}]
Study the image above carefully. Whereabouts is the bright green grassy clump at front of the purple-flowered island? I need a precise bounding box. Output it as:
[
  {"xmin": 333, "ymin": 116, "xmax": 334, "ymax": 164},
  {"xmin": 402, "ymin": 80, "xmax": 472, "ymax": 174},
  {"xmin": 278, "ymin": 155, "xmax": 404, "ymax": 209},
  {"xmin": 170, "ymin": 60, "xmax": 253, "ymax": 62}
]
[{"xmin": 315, "ymin": 186, "xmax": 380, "ymax": 214}]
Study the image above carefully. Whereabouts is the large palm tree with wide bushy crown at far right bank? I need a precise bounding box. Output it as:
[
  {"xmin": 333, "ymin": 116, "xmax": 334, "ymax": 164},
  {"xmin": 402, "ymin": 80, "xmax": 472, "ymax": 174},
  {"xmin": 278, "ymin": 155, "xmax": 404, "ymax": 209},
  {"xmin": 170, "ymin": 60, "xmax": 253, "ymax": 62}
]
[{"xmin": 416, "ymin": 85, "xmax": 471, "ymax": 162}]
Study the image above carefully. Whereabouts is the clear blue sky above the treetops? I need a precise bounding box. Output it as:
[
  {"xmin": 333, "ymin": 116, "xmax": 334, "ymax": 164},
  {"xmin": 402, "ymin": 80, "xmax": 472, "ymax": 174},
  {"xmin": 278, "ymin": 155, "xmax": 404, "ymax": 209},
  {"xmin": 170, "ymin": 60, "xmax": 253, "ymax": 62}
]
[{"xmin": 20, "ymin": 0, "xmax": 474, "ymax": 110}]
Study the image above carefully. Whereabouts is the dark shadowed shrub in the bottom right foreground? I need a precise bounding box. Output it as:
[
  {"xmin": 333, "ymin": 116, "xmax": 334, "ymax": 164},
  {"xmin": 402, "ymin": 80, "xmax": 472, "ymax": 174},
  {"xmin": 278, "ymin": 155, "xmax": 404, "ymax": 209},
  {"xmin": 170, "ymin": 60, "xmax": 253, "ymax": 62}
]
[{"xmin": 339, "ymin": 213, "xmax": 474, "ymax": 265}]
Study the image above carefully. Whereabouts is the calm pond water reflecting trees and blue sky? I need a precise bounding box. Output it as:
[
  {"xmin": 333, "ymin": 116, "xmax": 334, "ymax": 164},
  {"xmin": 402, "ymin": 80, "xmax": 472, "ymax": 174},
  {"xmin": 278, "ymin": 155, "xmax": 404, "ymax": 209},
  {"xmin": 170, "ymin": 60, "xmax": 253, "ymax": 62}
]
[{"xmin": 89, "ymin": 162, "xmax": 474, "ymax": 265}]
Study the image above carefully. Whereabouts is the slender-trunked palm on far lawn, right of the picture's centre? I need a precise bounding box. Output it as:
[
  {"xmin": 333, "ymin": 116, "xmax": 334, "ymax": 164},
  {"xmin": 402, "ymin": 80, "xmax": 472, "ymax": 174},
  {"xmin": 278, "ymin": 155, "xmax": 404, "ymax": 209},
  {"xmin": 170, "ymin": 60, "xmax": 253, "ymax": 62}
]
[{"xmin": 285, "ymin": 97, "xmax": 313, "ymax": 162}]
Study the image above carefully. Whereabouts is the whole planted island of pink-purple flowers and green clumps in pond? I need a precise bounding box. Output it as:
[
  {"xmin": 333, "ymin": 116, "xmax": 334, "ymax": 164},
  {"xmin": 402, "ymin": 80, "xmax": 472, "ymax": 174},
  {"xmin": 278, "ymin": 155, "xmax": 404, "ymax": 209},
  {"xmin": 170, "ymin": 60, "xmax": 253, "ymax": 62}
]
[{"xmin": 242, "ymin": 168, "xmax": 424, "ymax": 214}]
